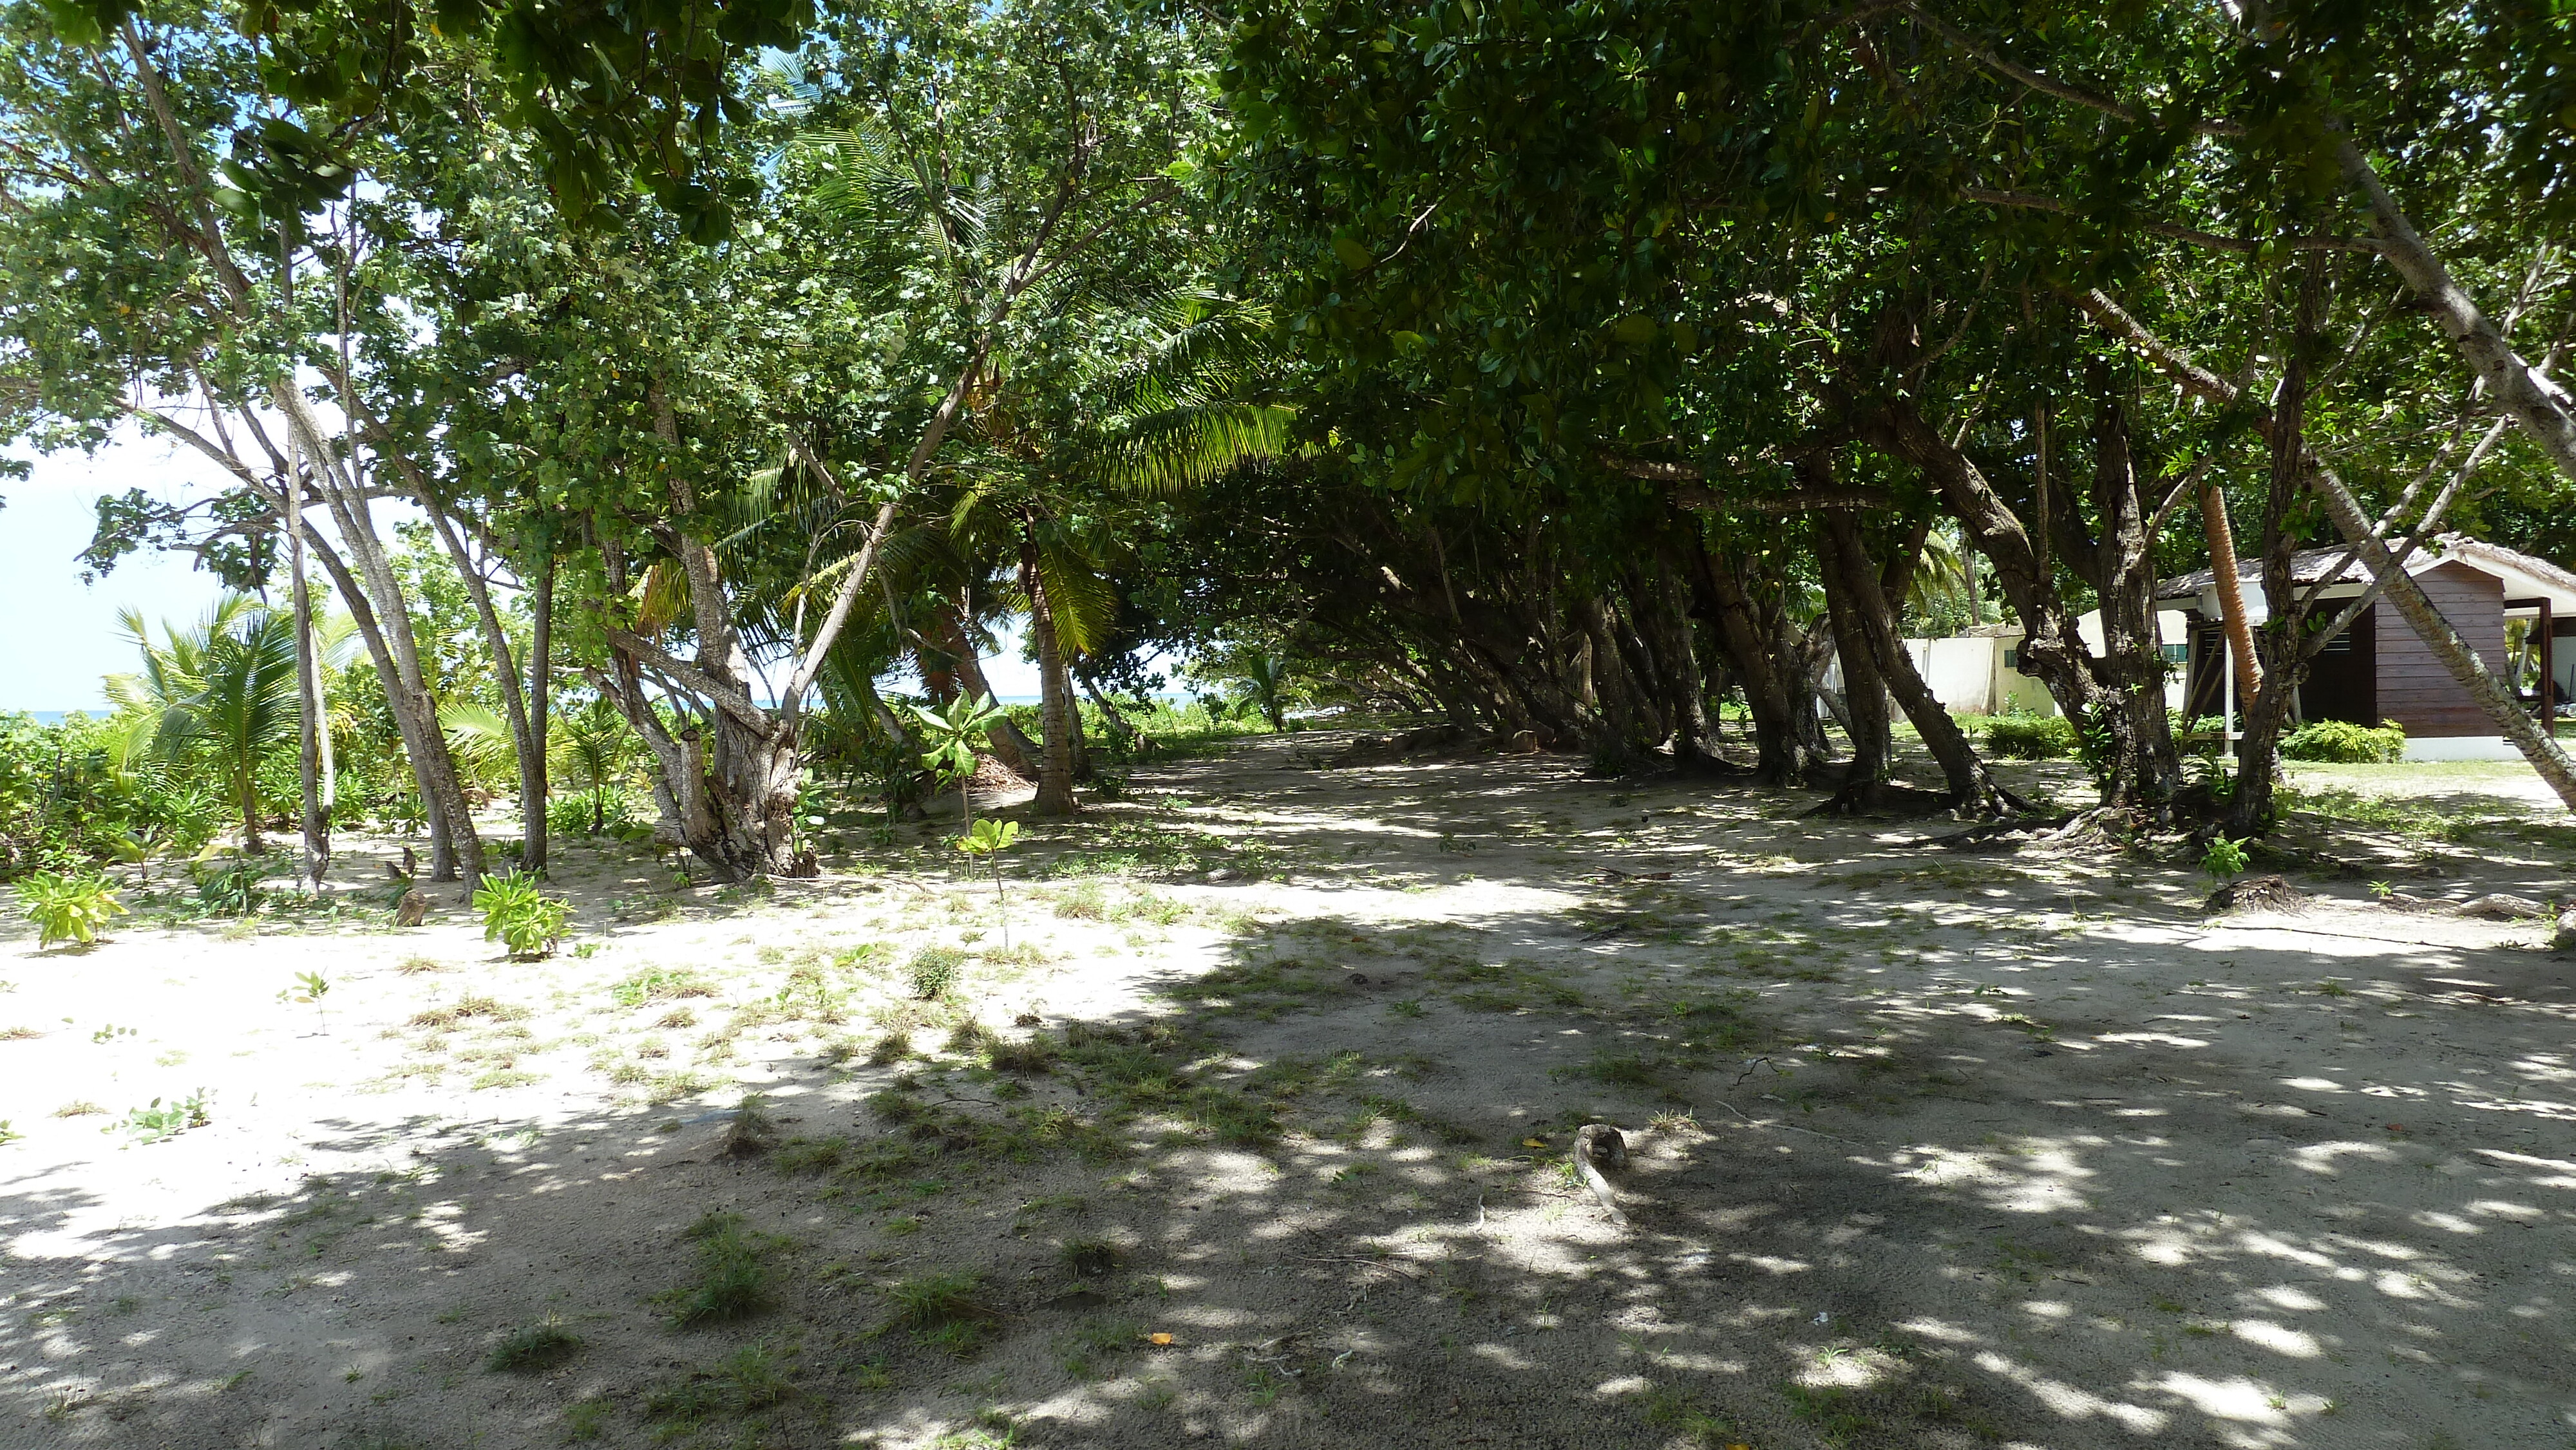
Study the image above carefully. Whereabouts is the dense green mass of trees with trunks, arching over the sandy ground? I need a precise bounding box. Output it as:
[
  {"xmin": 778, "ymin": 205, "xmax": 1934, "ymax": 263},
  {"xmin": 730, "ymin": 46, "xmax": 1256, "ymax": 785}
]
[{"xmin": 0, "ymin": 0, "xmax": 2576, "ymax": 878}]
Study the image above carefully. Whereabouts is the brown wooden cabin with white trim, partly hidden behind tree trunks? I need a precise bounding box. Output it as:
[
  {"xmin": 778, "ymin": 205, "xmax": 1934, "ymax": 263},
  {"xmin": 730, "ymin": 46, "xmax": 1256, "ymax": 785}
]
[{"xmin": 2156, "ymin": 536, "xmax": 2576, "ymax": 760}]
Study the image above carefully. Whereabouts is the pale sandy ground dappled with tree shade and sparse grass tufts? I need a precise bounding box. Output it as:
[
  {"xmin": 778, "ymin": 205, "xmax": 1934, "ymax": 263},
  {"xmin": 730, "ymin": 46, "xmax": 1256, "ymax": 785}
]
[{"xmin": 0, "ymin": 737, "xmax": 2576, "ymax": 1450}]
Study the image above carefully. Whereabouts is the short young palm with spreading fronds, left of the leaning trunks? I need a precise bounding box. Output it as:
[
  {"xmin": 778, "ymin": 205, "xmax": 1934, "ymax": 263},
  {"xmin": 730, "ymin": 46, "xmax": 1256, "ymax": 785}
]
[{"xmin": 108, "ymin": 595, "xmax": 307, "ymax": 852}]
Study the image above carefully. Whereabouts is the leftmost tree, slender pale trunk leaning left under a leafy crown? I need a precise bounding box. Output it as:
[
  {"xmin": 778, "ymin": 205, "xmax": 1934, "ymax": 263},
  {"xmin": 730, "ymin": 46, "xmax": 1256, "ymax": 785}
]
[{"xmin": 0, "ymin": 5, "xmax": 482, "ymax": 876}]
